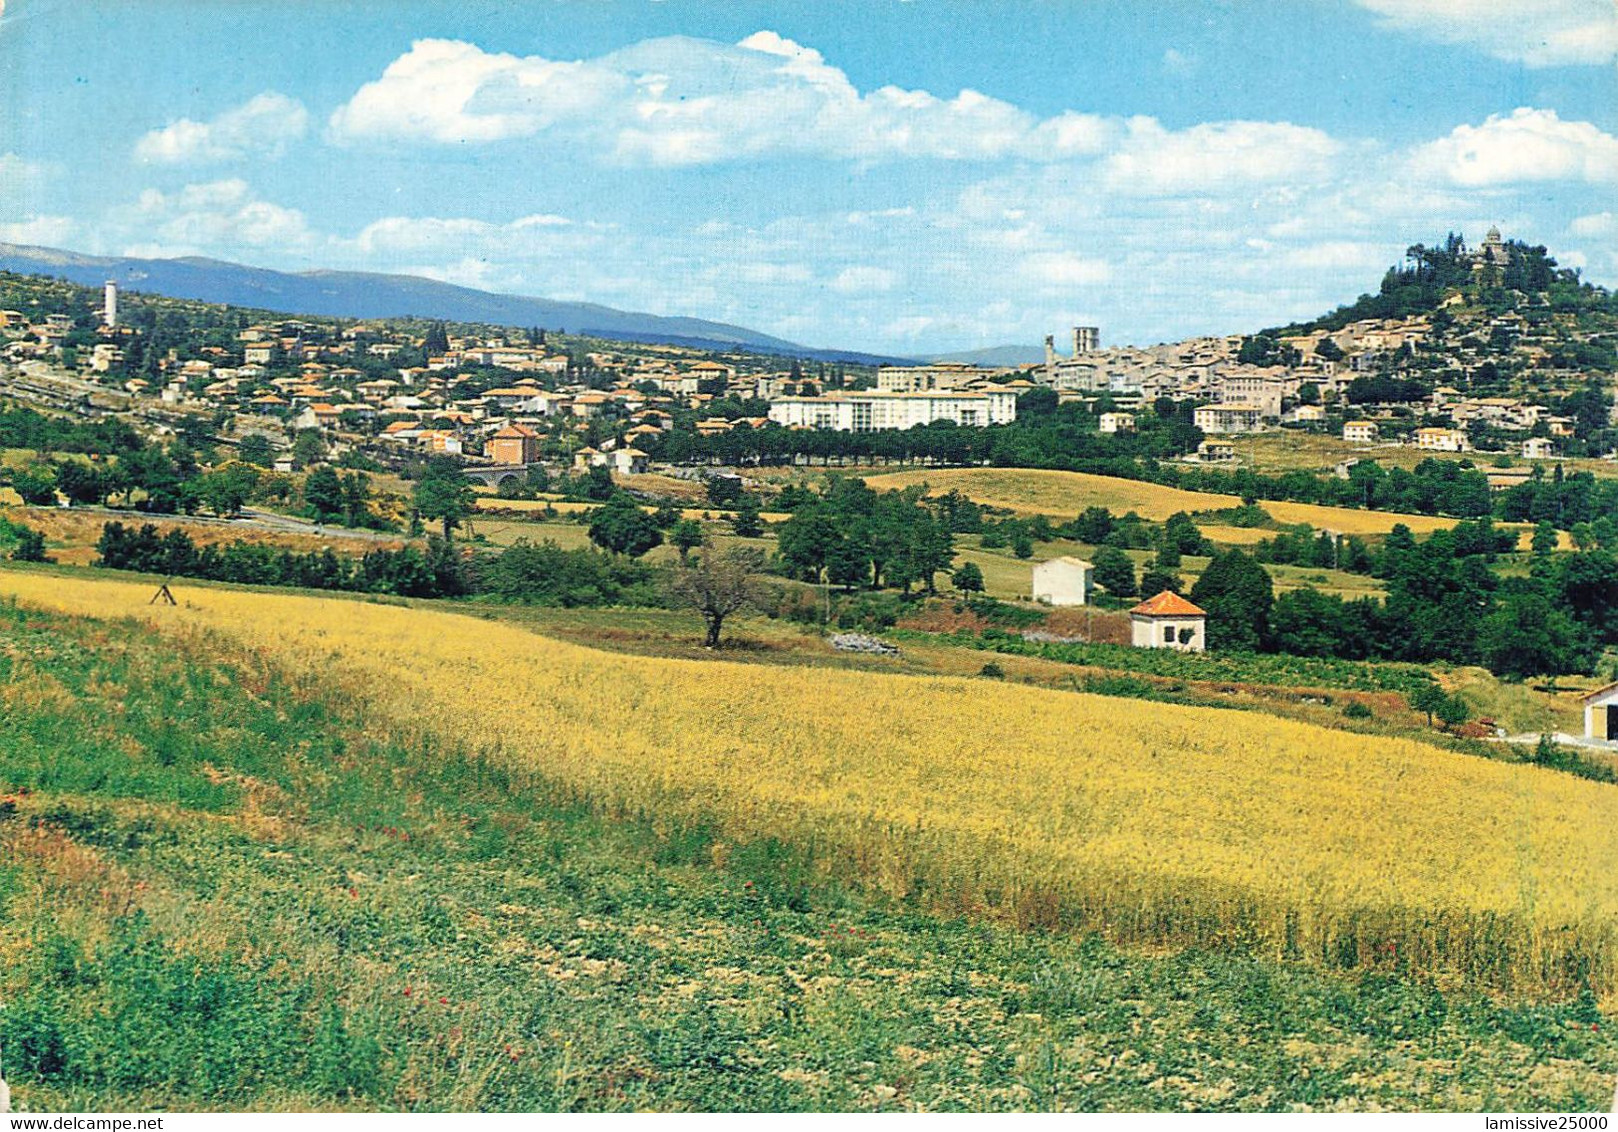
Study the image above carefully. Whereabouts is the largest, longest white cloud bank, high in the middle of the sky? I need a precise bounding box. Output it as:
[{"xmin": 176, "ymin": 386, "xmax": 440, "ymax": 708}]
[{"xmin": 330, "ymin": 31, "xmax": 1120, "ymax": 167}]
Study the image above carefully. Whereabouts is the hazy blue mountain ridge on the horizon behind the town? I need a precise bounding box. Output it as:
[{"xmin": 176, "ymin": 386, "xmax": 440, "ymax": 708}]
[{"xmin": 0, "ymin": 243, "xmax": 906, "ymax": 365}]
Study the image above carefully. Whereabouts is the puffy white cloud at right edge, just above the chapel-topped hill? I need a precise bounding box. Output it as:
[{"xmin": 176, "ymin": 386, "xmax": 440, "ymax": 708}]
[{"xmin": 1411, "ymin": 107, "xmax": 1618, "ymax": 186}]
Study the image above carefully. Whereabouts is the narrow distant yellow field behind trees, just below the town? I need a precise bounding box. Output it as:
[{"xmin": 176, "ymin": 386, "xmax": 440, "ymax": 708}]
[{"xmin": 866, "ymin": 467, "xmax": 1475, "ymax": 537}]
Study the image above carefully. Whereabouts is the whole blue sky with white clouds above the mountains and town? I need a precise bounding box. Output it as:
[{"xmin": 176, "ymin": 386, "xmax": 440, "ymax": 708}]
[{"xmin": 0, "ymin": 0, "xmax": 1618, "ymax": 353}]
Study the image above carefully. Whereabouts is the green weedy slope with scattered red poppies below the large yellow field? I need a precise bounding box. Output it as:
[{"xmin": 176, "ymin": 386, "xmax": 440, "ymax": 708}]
[{"xmin": 0, "ymin": 605, "xmax": 1618, "ymax": 1111}]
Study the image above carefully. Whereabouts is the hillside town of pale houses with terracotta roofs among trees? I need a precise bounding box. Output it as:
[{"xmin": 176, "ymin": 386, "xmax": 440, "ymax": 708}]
[{"xmin": 0, "ymin": 230, "xmax": 1613, "ymax": 485}]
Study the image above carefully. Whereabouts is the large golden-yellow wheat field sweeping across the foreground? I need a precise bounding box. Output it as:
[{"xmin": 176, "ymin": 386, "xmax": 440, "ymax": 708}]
[{"xmin": 0, "ymin": 571, "xmax": 1618, "ymax": 999}]
